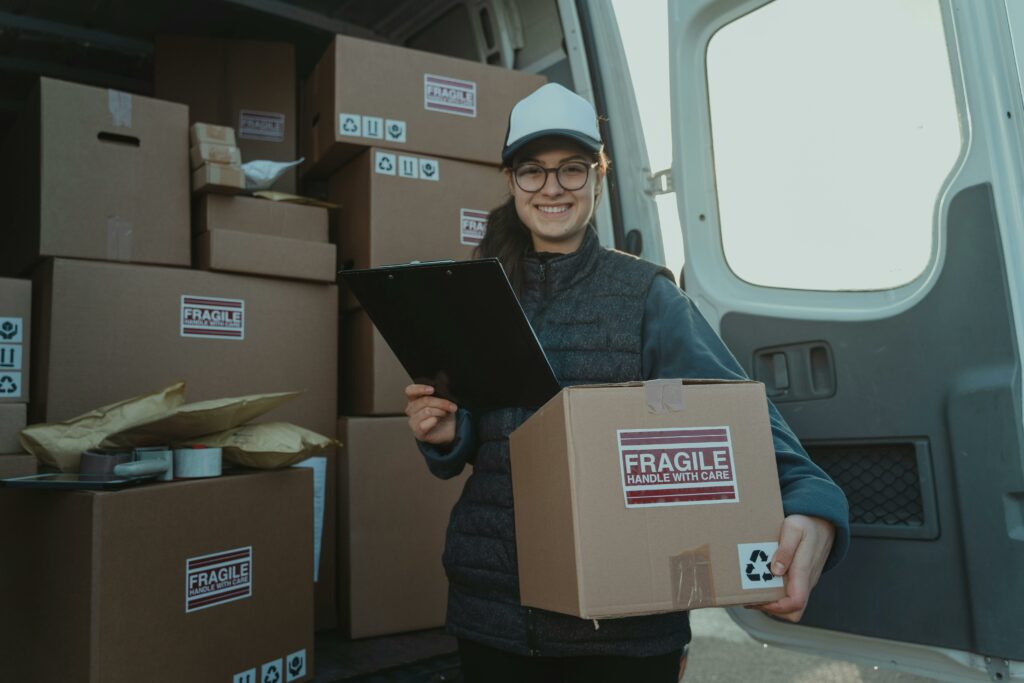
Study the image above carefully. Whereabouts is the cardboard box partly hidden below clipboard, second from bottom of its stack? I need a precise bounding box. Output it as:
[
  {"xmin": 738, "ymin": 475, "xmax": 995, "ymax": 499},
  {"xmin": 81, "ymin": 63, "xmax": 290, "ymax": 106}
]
[{"xmin": 338, "ymin": 308, "xmax": 413, "ymax": 416}]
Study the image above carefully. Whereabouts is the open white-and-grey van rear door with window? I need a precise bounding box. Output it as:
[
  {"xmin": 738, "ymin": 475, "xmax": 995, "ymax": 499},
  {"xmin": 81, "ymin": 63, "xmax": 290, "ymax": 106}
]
[{"xmin": 669, "ymin": 0, "xmax": 1024, "ymax": 681}]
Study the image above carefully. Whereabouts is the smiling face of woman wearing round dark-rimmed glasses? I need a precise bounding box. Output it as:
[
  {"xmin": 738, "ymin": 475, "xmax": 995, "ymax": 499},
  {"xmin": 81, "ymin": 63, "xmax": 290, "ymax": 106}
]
[{"xmin": 509, "ymin": 138, "xmax": 603, "ymax": 254}]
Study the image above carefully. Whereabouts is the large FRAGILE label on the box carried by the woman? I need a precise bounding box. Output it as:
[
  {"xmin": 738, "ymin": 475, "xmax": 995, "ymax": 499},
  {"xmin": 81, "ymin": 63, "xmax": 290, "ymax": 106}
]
[{"xmin": 617, "ymin": 427, "xmax": 739, "ymax": 508}]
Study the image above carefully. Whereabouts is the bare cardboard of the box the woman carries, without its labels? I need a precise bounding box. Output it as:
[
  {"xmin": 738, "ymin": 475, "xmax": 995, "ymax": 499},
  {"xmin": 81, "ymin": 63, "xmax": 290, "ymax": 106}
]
[{"xmin": 511, "ymin": 382, "xmax": 783, "ymax": 618}]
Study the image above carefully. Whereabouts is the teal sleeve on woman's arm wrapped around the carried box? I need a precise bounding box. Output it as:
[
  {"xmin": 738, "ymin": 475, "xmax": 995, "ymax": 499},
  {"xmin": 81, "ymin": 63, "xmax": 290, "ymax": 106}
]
[{"xmin": 642, "ymin": 278, "xmax": 850, "ymax": 569}]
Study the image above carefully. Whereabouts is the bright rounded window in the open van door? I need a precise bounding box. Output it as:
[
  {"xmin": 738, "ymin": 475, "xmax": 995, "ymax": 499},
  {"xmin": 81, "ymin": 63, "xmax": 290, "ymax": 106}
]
[{"xmin": 708, "ymin": 0, "xmax": 963, "ymax": 291}]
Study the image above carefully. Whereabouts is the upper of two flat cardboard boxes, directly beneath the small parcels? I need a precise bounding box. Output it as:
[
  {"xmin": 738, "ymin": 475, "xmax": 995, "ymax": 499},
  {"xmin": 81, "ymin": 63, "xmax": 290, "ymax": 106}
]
[{"xmin": 193, "ymin": 195, "xmax": 328, "ymax": 243}]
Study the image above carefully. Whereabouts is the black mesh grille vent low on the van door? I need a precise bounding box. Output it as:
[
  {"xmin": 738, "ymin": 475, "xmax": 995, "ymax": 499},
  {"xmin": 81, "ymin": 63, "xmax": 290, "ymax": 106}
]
[{"xmin": 807, "ymin": 443, "xmax": 925, "ymax": 527}]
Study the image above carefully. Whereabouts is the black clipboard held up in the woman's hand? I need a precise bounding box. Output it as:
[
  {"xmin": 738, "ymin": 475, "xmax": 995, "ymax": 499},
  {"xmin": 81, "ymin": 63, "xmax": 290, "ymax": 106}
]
[{"xmin": 340, "ymin": 258, "xmax": 561, "ymax": 411}]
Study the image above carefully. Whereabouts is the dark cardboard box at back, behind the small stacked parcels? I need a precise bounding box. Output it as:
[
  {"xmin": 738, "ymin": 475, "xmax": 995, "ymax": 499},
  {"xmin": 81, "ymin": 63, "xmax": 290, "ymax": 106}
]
[{"xmin": 154, "ymin": 36, "xmax": 298, "ymax": 193}]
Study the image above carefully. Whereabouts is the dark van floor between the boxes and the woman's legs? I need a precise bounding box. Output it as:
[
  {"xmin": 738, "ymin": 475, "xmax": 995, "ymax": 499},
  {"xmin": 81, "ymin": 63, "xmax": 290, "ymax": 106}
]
[{"xmin": 314, "ymin": 629, "xmax": 461, "ymax": 683}]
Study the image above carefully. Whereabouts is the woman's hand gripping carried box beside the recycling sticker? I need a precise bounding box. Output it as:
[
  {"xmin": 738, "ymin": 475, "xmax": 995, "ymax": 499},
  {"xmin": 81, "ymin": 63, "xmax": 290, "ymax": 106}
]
[{"xmin": 757, "ymin": 515, "xmax": 836, "ymax": 622}]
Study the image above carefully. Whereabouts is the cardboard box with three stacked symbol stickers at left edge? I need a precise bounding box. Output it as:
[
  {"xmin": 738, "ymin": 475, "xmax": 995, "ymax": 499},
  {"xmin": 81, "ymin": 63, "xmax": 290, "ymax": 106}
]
[{"xmin": 0, "ymin": 278, "xmax": 32, "ymax": 403}]
